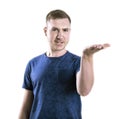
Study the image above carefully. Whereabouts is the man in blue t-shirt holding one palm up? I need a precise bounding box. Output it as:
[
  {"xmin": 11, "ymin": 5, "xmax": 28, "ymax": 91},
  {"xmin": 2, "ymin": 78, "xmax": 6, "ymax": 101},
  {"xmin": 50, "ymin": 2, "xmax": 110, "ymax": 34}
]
[{"xmin": 19, "ymin": 10, "xmax": 109, "ymax": 119}]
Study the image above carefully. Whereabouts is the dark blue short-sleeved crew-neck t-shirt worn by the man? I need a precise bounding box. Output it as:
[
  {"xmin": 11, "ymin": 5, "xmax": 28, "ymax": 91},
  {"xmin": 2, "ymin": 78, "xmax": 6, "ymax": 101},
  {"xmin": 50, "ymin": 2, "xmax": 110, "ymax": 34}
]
[{"xmin": 23, "ymin": 51, "xmax": 82, "ymax": 119}]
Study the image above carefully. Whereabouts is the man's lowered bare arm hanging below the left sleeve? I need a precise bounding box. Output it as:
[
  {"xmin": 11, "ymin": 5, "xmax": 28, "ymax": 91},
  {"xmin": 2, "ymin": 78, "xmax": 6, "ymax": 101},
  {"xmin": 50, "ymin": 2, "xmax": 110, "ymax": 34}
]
[{"xmin": 18, "ymin": 89, "xmax": 33, "ymax": 119}]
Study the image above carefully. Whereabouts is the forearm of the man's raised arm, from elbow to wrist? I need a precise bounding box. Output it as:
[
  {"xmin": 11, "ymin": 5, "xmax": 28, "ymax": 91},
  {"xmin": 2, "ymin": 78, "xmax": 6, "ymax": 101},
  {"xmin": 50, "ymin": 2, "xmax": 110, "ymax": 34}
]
[{"xmin": 77, "ymin": 55, "xmax": 94, "ymax": 96}]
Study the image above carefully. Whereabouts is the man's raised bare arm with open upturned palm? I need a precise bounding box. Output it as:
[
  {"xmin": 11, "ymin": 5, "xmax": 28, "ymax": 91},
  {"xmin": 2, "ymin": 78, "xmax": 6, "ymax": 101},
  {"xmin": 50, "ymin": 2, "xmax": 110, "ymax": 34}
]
[{"xmin": 76, "ymin": 44, "xmax": 110, "ymax": 96}]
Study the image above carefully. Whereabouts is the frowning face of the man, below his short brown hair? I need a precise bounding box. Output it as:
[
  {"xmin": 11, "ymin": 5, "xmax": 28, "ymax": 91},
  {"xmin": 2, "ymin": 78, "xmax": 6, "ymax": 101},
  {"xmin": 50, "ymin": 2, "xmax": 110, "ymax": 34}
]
[{"xmin": 44, "ymin": 18, "xmax": 71, "ymax": 51}]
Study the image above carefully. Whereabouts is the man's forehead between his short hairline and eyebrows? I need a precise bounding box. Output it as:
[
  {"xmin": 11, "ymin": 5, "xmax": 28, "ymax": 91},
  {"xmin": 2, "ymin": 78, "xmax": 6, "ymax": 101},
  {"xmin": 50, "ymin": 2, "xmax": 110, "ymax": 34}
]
[{"xmin": 47, "ymin": 18, "xmax": 71, "ymax": 28}]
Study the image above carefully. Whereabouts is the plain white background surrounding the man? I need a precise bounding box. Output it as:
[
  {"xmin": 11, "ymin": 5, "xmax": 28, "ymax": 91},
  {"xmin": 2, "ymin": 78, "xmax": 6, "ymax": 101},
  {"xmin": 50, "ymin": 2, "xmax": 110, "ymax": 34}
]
[{"xmin": 0, "ymin": 0, "xmax": 120, "ymax": 119}]
